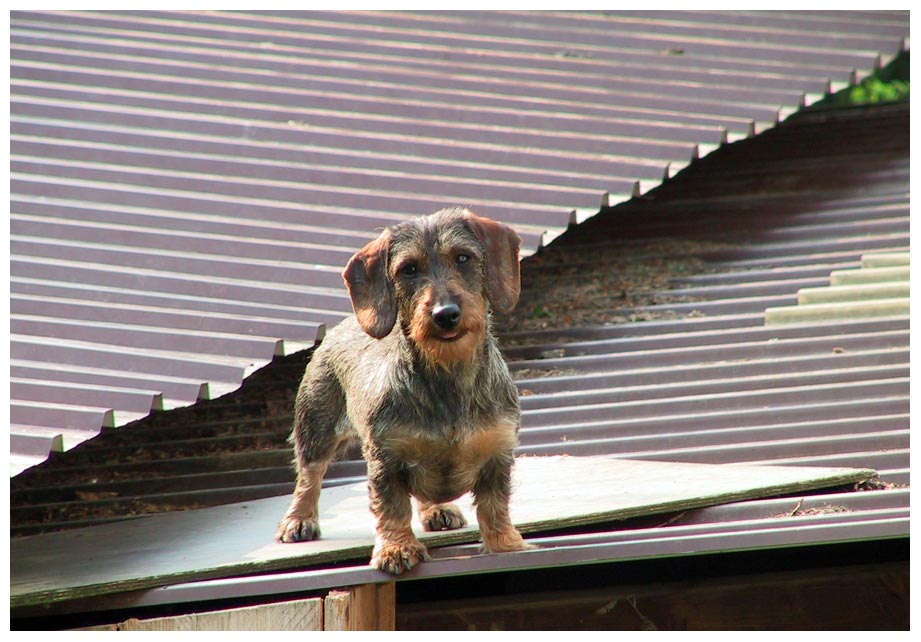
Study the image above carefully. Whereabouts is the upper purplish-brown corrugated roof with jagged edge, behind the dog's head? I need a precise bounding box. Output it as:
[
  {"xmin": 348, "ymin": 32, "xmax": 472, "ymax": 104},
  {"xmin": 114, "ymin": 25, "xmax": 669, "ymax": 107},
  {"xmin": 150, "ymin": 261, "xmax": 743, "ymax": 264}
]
[{"xmin": 10, "ymin": 11, "xmax": 908, "ymax": 470}]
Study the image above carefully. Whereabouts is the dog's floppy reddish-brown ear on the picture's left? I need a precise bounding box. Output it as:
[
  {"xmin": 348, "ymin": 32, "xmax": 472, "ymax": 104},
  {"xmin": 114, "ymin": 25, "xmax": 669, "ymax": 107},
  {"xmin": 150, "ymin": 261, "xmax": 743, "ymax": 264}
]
[{"xmin": 342, "ymin": 230, "xmax": 397, "ymax": 339}]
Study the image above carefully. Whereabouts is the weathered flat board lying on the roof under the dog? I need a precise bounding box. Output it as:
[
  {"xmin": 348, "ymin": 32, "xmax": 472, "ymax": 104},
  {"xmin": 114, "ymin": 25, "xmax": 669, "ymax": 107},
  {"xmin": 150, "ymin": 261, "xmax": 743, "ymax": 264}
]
[{"xmin": 10, "ymin": 457, "xmax": 875, "ymax": 608}]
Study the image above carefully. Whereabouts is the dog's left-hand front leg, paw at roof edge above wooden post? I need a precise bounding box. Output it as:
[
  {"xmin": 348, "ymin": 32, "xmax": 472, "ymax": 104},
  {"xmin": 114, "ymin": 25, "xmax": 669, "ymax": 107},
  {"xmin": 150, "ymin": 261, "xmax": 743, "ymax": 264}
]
[{"xmin": 368, "ymin": 460, "xmax": 429, "ymax": 575}]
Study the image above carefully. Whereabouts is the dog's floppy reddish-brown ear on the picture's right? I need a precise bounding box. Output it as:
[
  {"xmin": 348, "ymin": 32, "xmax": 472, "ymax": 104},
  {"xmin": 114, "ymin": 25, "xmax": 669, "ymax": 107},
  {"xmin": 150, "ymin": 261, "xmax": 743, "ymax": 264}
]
[{"xmin": 467, "ymin": 211, "xmax": 521, "ymax": 313}]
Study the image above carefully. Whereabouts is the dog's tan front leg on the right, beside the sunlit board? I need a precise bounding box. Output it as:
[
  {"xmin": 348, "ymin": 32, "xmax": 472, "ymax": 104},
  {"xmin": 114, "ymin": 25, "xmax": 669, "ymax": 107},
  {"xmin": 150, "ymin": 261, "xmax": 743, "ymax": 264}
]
[{"xmin": 473, "ymin": 452, "xmax": 534, "ymax": 553}]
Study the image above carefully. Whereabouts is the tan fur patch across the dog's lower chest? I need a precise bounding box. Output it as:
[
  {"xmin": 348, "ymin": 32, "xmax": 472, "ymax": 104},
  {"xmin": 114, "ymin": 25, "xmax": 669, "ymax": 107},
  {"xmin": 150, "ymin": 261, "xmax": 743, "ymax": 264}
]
[{"xmin": 381, "ymin": 421, "xmax": 518, "ymax": 503}]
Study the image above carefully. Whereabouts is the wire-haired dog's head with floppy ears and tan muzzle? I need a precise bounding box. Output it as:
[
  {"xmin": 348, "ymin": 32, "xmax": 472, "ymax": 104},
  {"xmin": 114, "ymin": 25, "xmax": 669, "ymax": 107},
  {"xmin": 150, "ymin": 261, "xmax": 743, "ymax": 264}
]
[{"xmin": 343, "ymin": 207, "xmax": 521, "ymax": 363}]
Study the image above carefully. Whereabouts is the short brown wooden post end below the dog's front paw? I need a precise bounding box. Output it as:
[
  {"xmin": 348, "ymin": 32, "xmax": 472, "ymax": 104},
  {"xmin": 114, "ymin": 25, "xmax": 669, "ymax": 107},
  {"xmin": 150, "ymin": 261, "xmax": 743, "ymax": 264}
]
[{"xmin": 323, "ymin": 582, "xmax": 396, "ymax": 631}]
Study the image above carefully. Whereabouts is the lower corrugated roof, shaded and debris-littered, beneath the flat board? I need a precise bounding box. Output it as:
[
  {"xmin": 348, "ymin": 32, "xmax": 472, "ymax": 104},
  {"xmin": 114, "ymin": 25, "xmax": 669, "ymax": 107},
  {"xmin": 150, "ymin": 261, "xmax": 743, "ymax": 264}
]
[{"xmin": 11, "ymin": 104, "xmax": 910, "ymax": 610}]
